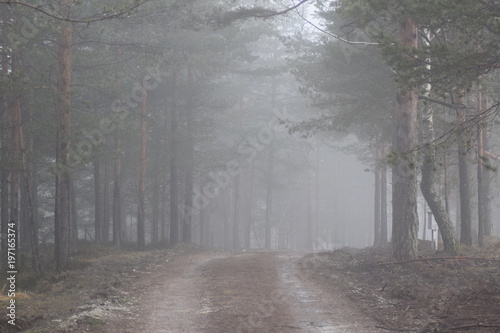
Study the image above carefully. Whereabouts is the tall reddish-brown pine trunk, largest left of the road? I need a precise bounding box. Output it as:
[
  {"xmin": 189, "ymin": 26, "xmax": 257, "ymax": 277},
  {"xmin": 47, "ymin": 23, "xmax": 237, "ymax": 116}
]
[{"xmin": 55, "ymin": 0, "xmax": 73, "ymax": 271}]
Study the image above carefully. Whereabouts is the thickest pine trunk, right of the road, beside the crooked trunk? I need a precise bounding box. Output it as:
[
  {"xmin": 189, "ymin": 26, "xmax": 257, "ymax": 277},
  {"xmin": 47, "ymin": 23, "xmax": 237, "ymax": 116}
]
[{"xmin": 392, "ymin": 19, "xmax": 418, "ymax": 260}]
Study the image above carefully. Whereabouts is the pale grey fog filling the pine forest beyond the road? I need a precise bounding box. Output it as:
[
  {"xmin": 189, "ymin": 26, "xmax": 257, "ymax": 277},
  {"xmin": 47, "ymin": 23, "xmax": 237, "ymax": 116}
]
[{"xmin": 1, "ymin": 1, "xmax": 499, "ymax": 265}]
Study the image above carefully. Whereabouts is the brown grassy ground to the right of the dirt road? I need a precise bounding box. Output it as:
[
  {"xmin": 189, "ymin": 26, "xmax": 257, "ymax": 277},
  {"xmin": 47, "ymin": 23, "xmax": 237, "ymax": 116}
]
[{"xmin": 300, "ymin": 239, "xmax": 500, "ymax": 333}]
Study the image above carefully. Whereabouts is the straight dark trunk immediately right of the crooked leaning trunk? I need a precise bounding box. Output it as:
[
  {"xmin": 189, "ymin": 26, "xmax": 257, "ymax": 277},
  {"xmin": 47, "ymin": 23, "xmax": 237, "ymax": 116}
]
[{"xmin": 457, "ymin": 94, "xmax": 472, "ymax": 246}]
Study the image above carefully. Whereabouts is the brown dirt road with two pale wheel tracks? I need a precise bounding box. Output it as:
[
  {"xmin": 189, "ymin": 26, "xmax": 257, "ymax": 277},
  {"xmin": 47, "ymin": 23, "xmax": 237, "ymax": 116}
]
[{"xmin": 102, "ymin": 251, "xmax": 379, "ymax": 333}]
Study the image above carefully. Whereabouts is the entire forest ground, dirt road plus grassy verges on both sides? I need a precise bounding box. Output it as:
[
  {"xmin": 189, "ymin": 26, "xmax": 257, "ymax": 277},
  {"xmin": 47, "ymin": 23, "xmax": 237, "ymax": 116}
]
[{"xmin": 0, "ymin": 239, "xmax": 500, "ymax": 333}]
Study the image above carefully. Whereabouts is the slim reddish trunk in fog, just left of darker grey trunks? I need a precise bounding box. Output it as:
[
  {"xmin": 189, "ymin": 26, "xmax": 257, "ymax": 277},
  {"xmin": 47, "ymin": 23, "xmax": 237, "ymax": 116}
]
[{"xmin": 137, "ymin": 87, "xmax": 148, "ymax": 251}]
